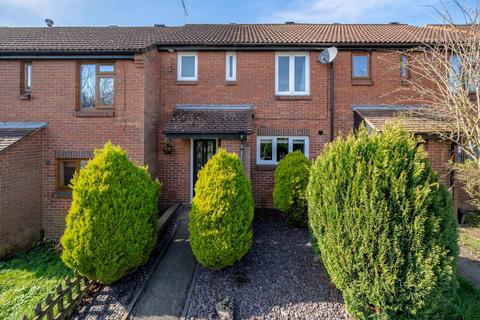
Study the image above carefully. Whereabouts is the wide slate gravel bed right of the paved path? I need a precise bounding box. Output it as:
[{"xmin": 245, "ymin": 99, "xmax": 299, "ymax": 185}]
[{"xmin": 187, "ymin": 212, "xmax": 348, "ymax": 319}]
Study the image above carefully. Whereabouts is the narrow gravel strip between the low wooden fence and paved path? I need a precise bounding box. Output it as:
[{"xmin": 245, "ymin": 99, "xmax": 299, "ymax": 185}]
[{"xmin": 72, "ymin": 218, "xmax": 175, "ymax": 320}]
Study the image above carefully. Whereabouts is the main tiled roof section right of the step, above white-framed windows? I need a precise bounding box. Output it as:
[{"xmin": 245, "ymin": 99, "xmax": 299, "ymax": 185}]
[{"xmin": 159, "ymin": 23, "xmax": 440, "ymax": 45}]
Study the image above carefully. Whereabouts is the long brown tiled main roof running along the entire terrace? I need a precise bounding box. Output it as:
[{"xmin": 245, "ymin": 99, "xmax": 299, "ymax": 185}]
[{"xmin": 0, "ymin": 24, "xmax": 442, "ymax": 54}]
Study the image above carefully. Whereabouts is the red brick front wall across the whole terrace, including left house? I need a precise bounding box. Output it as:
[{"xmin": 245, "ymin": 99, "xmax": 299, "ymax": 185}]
[{"xmin": 0, "ymin": 46, "xmax": 464, "ymax": 238}]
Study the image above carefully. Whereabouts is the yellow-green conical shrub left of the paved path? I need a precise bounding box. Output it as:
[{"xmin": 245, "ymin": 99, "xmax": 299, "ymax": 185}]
[{"xmin": 61, "ymin": 142, "xmax": 160, "ymax": 283}]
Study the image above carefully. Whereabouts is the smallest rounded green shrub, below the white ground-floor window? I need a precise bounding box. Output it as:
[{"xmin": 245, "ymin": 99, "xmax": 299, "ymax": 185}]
[{"xmin": 273, "ymin": 151, "xmax": 310, "ymax": 226}]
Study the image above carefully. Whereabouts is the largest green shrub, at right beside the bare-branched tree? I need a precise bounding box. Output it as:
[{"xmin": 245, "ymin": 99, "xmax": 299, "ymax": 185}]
[{"xmin": 307, "ymin": 124, "xmax": 458, "ymax": 319}]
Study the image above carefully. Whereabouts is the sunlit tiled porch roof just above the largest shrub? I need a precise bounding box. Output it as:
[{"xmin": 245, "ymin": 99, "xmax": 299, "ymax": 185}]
[{"xmin": 354, "ymin": 107, "xmax": 448, "ymax": 134}]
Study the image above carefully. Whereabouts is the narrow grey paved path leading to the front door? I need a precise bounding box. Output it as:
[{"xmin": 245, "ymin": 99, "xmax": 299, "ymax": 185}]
[{"xmin": 133, "ymin": 207, "xmax": 196, "ymax": 320}]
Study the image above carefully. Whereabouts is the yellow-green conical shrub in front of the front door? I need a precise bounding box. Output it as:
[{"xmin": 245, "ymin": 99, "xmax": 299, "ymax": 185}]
[{"xmin": 188, "ymin": 149, "xmax": 254, "ymax": 269}]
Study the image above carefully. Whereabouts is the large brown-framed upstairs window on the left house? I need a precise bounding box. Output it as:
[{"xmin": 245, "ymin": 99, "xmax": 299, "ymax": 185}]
[{"xmin": 80, "ymin": 63, "xmax": 115, "ymax": 110}]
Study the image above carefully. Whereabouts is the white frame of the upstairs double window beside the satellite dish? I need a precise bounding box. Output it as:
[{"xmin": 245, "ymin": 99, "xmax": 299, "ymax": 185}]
[{"xmin": 275, "ymin": 52, "xmax": 310, "ymax": 96}]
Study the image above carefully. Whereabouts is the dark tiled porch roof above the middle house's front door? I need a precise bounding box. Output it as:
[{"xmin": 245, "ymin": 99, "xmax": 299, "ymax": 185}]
[{"xmin": 164, "ymin": 106, "xmax": 253, "ymax": 136}]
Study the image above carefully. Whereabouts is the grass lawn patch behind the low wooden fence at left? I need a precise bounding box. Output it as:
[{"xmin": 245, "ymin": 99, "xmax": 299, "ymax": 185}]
[{"xmin": 0, "ymin": 244, "xmax": 73, "ymax": 319}]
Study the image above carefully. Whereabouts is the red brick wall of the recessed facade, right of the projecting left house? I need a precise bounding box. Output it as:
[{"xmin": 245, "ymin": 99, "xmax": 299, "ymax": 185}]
[{"xmin": 159, "ymin": 51, "xmax": 420, "ymax": 207}]
